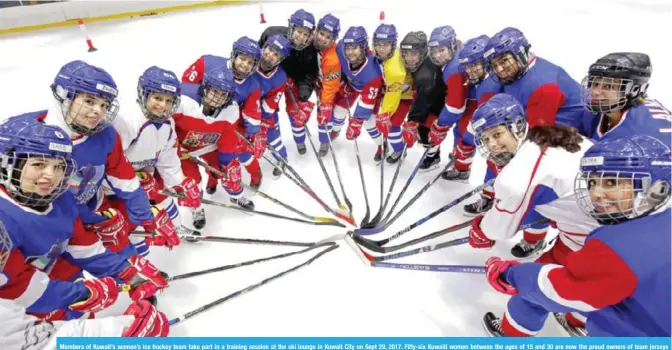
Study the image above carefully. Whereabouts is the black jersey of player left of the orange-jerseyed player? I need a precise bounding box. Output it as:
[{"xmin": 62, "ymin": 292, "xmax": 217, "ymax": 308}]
[{"xmin": 259, "ymin": 26, "xmax": 319, "ymax": 101}]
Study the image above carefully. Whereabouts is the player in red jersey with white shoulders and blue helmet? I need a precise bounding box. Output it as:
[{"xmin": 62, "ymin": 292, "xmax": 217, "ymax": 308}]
[{"xmin": 173, "ymin": 65, "xmax": 254, "ymax": 230}]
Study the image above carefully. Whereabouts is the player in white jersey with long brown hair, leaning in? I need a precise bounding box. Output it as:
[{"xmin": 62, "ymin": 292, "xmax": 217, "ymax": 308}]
[{"xmin": 469, "ymin": 94, "xmax": 591, "ymax": 258}]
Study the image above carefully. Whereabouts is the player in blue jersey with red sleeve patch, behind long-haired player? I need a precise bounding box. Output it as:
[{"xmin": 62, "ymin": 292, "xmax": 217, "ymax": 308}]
[{"xmin": 484, "ymin": 27, "xmax": 592, "ymax": 254}]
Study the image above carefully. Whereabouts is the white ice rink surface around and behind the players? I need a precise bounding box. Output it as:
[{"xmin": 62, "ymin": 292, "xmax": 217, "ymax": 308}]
[{"xmin": 0, "ymin": 0, "xmax": 672, "ymax": 336}]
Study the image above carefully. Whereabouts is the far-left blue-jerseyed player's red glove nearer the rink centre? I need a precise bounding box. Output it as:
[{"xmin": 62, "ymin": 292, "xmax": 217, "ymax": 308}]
[{"xmin": 119, "ymin": 255, "xmax": 168, "ymax": 301}]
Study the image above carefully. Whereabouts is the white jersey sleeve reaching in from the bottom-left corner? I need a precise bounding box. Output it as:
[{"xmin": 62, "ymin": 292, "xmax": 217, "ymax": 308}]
[{"xmin": 0, "ymin": 299, "xmax": 134, "ymax": 350}]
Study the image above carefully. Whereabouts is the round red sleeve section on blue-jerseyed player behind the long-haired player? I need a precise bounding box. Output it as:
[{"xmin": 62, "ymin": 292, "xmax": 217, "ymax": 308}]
[{"xmin": 525, "ymin": 83, "xmax": 567, "ymax": 127}]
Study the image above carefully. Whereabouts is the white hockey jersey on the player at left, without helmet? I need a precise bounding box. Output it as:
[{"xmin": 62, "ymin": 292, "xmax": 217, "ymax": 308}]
[{"xmin": 113, "ymin": 112, "xmax": 184, "ymax": 187}]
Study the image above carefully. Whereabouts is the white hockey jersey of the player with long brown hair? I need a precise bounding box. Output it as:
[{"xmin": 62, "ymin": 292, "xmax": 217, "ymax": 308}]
[{"xmin": 481, "ymin": 139, "xmax": 592, "ymax": 250}]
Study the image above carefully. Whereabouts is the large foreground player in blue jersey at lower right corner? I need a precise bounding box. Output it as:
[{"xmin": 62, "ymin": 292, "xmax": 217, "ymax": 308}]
[{"xmin": 483, "ymin": 135, "xmax": 672, "ymax": 337}]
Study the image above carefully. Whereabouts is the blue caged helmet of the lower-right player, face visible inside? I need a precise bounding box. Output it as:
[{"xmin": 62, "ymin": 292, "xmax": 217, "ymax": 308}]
[{"xmin": 574, "ymin": 135, "xmax": 672, "ymax": 225}]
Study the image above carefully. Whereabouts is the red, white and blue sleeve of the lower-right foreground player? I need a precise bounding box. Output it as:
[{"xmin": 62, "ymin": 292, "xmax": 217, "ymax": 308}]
[{"xmin": 505, "ymin": 239, "xmax": 638, "ymax": 312}]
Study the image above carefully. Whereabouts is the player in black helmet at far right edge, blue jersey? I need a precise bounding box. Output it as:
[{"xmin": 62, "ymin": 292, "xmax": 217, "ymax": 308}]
[{"xmin": 581, "ymin": 52, "xmax": 672, "ymax": 147}]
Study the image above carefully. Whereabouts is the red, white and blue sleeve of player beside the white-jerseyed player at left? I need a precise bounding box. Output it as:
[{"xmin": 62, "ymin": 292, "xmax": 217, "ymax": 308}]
[{"xmin": 105, "ymin": 131, "xmax": 154, "ymax": 225}]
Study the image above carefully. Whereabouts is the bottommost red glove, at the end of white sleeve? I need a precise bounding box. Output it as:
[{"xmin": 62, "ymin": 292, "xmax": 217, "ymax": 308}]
[{"xmin": 121, "ymin": 300, "xmax": 170, "ymax": 337}]
